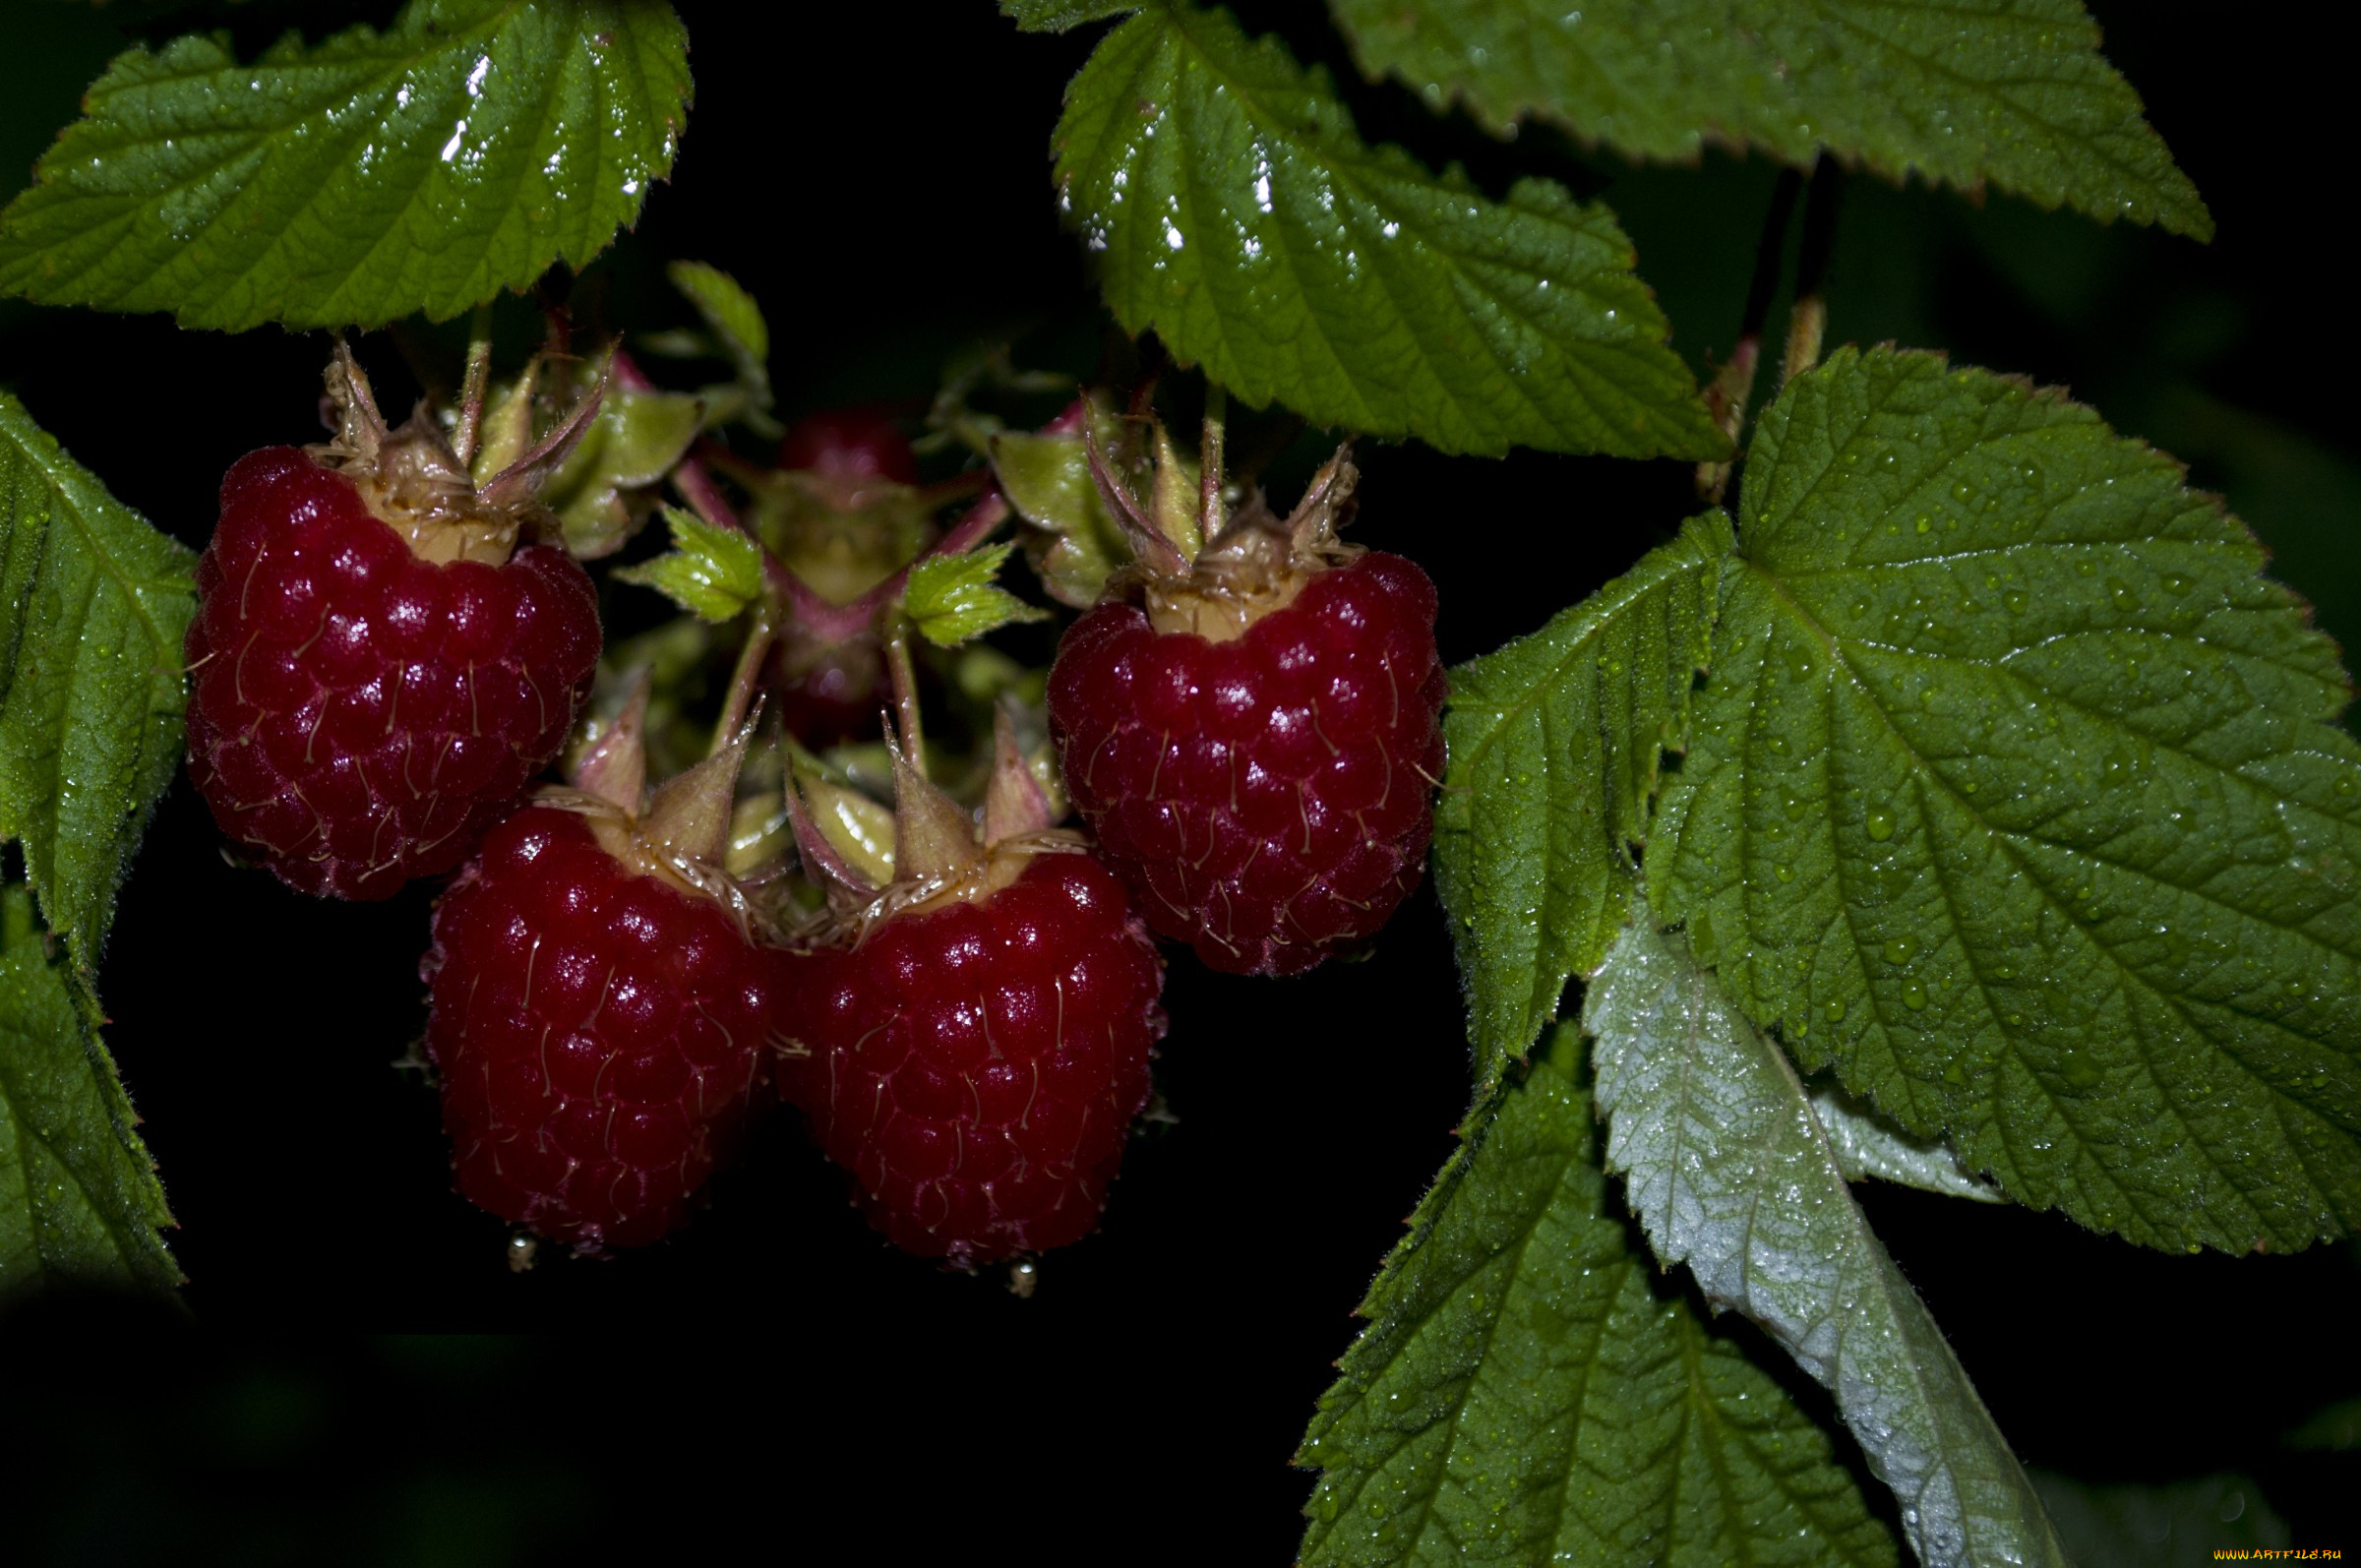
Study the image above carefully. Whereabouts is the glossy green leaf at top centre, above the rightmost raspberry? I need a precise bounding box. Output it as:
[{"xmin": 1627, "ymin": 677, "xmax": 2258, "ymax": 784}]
[{"xmin": 1056, "ymin": 0, "xmax": 1725, "ymax": 458}]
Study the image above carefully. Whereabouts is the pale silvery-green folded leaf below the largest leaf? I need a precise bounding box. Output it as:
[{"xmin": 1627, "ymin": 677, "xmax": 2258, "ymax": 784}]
[{"xmin": 1582, "ymin": 907, "xmax": 2066, "ymax": 1568}]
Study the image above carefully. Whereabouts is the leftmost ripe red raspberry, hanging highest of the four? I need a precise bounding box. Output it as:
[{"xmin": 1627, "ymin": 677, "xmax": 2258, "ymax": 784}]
[{"xmin": 187, "ymin": 349, "xmax": 600, "ymax": 900}]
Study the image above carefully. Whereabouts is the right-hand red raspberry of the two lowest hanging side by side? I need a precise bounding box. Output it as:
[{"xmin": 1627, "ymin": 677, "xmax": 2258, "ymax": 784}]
[{"xmin": 779, "ymin": 722, "xmax": 1164, "ymax": 1268}]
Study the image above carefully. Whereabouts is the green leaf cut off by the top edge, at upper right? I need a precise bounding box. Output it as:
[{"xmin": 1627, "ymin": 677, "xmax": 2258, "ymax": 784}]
[{"xmin": 1332, "ymin": 0, "xmax": 2212, "ymax": 238}]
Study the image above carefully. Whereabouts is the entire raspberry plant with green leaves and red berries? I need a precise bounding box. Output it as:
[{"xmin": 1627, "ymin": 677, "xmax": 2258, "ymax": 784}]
[{"xmin": 0, "ymin": 0, "xmax": 2361, "ymax": 1568}]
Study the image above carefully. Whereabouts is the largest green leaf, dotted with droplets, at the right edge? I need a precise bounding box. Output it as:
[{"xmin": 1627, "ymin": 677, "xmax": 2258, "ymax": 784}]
[{"xmin": 1651, "ymin": 349, "xmax": 2361, "ymax": 1251}]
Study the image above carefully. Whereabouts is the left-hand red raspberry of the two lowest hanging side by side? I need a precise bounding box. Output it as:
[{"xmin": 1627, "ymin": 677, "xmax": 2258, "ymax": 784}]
[{"xmin": 420, "ymin": 758, "xmax": 786, "ymax": 1251}]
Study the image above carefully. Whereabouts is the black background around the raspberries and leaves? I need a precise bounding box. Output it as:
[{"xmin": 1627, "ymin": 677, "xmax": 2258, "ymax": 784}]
[{"xmin": 0, "ymin": 0, "xmax": 2361, "ymax": 1563}]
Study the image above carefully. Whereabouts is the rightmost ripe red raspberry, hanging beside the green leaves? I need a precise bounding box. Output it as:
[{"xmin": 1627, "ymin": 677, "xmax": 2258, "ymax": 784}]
[{"xmin": 1049, "ymin": 446, "xmax": 1445, "ymax": 975}]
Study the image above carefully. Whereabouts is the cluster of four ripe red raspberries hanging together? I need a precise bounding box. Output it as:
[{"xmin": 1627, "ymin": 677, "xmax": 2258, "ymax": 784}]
[{"xmin": 187, "ymin": 401, "xmax": 1442, "ymax": 1266}]
